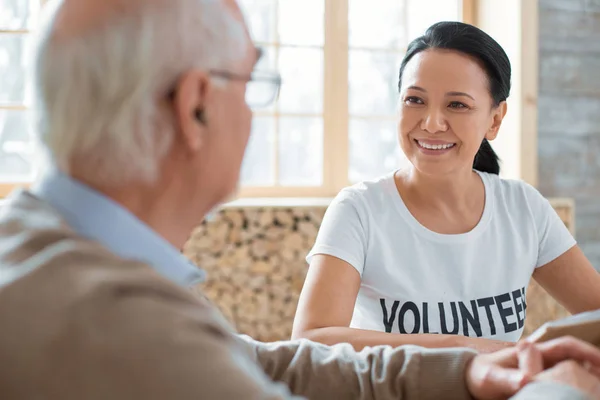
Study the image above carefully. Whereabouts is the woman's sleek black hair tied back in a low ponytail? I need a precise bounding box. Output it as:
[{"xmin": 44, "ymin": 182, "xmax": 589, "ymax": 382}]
[{"xmin": 398, "ymin": 22, "xmax": 511, "ymax": 175}]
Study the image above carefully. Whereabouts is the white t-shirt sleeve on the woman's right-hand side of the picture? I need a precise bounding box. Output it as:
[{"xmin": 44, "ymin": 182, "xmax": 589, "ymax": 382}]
[{"xmin": 526, "ymin": 185, "xmax": 577, "ymax": 268}]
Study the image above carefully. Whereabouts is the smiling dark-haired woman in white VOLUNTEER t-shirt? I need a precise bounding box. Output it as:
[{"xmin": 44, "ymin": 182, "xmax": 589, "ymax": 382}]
[{"xmin": 294, "ymin": 22, "xmax": 600, "ymax": 351}]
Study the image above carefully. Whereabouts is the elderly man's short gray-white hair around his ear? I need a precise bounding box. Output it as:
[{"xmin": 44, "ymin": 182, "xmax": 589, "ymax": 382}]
[{"xmin": 35, "ymin": 0, "xmax": 246, "ymax": 185}]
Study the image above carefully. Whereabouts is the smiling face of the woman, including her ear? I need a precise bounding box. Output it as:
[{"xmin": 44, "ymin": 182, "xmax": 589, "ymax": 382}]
[{"xmin": 398, "ymin": 49, "xmax": 506, "ymax": 175}]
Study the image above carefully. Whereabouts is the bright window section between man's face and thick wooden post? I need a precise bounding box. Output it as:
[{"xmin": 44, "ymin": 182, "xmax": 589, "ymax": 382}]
[{"xmin": 240, "ymin": 0, "xmax": 325, "ymax": 195}]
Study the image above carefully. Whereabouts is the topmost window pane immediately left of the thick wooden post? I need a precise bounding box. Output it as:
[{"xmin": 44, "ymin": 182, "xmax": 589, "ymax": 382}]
[{"xmin": 279, "ymin": 0, "xmax": 324, "ymax": 46}]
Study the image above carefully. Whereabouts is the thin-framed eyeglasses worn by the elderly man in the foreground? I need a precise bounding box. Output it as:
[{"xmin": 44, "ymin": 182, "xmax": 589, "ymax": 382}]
[{"xmin": 169, "ymin": 70, "xmax": 281, "ymax": 109}]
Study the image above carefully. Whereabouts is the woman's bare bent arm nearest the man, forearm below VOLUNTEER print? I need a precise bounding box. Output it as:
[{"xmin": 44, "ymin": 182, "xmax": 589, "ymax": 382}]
[{"xmin": 292, "ymin": 255, "xmax": 514, "ymax": 353}]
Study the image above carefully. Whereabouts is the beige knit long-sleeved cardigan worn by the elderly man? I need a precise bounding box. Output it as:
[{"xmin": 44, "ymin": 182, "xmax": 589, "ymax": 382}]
[{"xmin": 0, "ymin": 192, "xmax": 583, "ymax": 400}]
